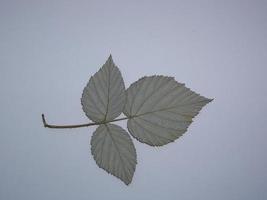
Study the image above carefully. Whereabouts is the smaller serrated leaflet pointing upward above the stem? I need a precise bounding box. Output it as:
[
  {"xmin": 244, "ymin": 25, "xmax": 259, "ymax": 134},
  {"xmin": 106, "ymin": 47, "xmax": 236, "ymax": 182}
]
[{"xmin": 81, "ymin": 56, "xmax": 125, "ymax": 122}]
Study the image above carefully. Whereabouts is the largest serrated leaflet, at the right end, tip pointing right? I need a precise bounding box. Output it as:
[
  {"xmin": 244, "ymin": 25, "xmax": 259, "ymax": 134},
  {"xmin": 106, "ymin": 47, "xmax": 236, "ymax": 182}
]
[{"xmin": 123, "ymin": 76, "xmax": 214, "ymax": 146}]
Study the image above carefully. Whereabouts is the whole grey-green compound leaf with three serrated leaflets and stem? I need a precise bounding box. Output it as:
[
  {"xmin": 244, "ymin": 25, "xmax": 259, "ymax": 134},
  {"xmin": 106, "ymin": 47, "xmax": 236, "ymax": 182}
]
[{"xmin": 42, "ymin": 56, "xmax": 212, "ymax": 185}]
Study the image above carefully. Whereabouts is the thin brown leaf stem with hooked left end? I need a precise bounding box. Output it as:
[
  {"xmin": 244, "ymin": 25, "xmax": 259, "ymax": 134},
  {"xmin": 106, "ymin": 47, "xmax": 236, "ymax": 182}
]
[{"xmin": 42, "ymin": 114, "xmax": 128, "ymax": 129}]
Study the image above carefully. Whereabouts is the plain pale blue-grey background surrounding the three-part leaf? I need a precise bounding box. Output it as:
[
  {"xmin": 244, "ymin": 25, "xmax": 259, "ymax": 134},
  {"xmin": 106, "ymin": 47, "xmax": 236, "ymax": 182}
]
[{"xmin": 0, "ymin": 0, "xmax": 267, "ymax": 200}]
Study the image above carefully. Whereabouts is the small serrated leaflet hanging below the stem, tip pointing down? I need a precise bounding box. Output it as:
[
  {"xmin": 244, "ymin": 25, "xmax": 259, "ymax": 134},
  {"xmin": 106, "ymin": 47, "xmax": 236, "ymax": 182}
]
[{"xmin": 91, "ymin": 124, "xmax": 137, "ymax": 185}]
